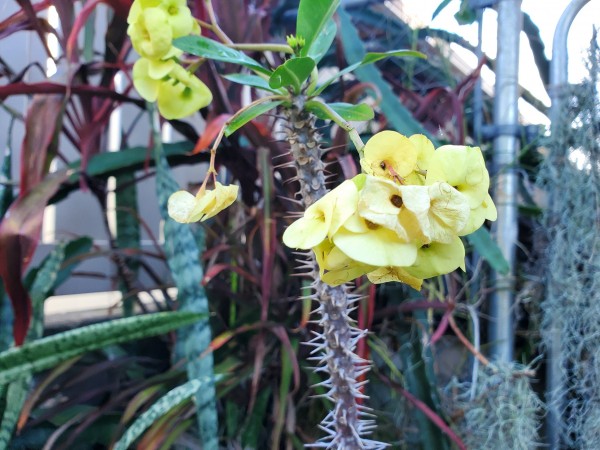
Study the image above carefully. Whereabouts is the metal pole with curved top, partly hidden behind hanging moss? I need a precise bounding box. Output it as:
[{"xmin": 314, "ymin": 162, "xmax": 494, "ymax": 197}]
[{"xmin": 546, "ymin": 0, "xmax": 589, "ymax": 450}]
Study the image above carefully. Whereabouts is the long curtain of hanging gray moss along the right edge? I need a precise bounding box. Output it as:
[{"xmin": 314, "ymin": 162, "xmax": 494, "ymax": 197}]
[{"xmin": 539, "ymin": 37, "xmax": 600, "ymax": 449}]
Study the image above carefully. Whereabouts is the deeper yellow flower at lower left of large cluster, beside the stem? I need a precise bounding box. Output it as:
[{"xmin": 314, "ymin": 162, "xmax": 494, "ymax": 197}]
[{"xmin": 313, "ymin": 239, "xmax": 374, "ymax": 286}]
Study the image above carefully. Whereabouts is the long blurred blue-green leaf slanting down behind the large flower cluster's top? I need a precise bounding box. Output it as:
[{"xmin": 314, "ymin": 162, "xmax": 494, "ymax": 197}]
[{"xmin": 338, "ymin": 8, "xmax": 435, "ymax": 139}]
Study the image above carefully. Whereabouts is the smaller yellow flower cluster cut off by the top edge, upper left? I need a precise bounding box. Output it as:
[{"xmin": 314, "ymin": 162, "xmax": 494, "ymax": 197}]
[{"xmin": 127, "ymin": 0, "xmax": 212, "ymax": 119}]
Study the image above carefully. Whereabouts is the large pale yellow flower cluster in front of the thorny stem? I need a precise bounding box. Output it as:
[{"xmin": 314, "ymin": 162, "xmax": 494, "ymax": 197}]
[{"xmin": 283, "ymin": 131, "xmax": 496, "ymax": 289}]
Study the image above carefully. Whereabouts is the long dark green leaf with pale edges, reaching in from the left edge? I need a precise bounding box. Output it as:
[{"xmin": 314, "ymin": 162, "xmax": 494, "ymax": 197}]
[{"xmin": 0, "ymin": 311, "xmax": 203, "ymax": 384}]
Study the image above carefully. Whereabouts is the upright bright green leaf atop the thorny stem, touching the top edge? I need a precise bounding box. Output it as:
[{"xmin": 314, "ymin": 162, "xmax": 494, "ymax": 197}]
[{"xmin": 296, "ymin": 0, "xmax": 340, "ymax": 56}]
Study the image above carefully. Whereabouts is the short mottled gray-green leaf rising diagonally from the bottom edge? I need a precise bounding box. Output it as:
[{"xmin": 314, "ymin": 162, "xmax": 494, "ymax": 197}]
[{"xmin": 113, "ymin": 377, "xmax": 217, "ymax": 450}]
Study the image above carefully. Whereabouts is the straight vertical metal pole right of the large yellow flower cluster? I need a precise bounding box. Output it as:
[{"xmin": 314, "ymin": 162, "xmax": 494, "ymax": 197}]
[{"xmin": 490, "ymin": 0, "xmax": 523, "ymax": 362}]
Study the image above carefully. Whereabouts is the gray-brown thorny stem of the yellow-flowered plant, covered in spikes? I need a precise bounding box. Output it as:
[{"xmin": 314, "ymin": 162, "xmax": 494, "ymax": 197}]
[{"xmin": 286, "ymin": 103, "xmax": 385, "ymax": 450}]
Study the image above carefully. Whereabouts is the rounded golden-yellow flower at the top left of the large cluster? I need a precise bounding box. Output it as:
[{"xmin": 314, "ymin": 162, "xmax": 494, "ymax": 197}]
[{"xmin": 360, "ymin": 130, "xmax": 418, "ymax": 181}]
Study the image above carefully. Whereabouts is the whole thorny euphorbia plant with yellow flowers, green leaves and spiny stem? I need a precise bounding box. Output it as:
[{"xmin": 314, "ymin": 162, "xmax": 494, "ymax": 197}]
[{"xmin": 129, "ymin": 0, "xmax": 495, "ymax": 449}]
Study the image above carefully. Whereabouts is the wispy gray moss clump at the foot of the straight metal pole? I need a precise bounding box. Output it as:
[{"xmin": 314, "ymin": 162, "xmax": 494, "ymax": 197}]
[{"xmin": 444, "ymin": 363, "xmax": 543, "ymax": 450}]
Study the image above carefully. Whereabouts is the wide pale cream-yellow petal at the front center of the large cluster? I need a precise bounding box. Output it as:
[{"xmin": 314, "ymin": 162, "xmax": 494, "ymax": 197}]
[{"xmin": 332, "ymin": 214, "xmax": 417, "ymax": 266}]
